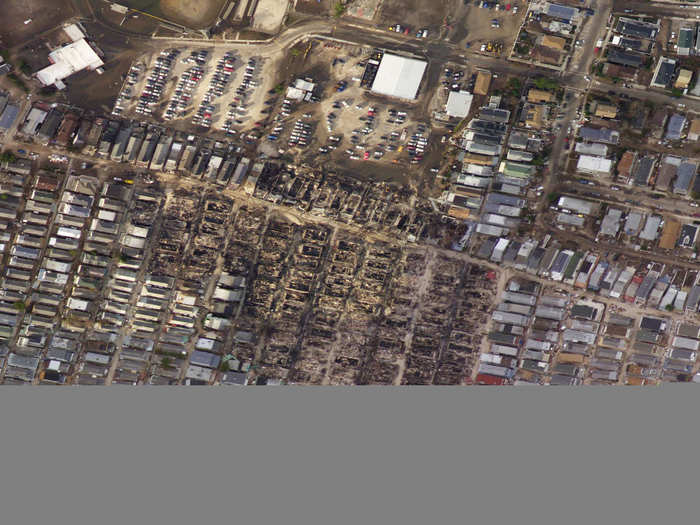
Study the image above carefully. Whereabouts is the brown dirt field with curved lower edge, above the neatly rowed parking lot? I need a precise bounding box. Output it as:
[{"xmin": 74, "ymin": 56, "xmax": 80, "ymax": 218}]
[{"xmin": 120, "ymin": 0, "xmax": 227, "ymax": 29}]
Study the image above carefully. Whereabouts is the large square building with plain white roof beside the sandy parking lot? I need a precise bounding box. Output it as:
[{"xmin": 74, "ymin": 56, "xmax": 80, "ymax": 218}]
[{"xmin": 372, "ymin": 53, "xmax": 428, "ymax": 100}]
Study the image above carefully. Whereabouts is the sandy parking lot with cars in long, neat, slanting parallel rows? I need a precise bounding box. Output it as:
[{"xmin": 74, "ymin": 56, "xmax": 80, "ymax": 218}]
[{"xmin": 113, "ymin": 47, "xmax": 274, "ymax": 134}]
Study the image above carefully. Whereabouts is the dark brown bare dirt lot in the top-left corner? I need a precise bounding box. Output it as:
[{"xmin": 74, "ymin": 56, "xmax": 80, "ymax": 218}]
[{"xmin": 0, "ymin": 0, "xmax": 77, "ymax": 47}]
